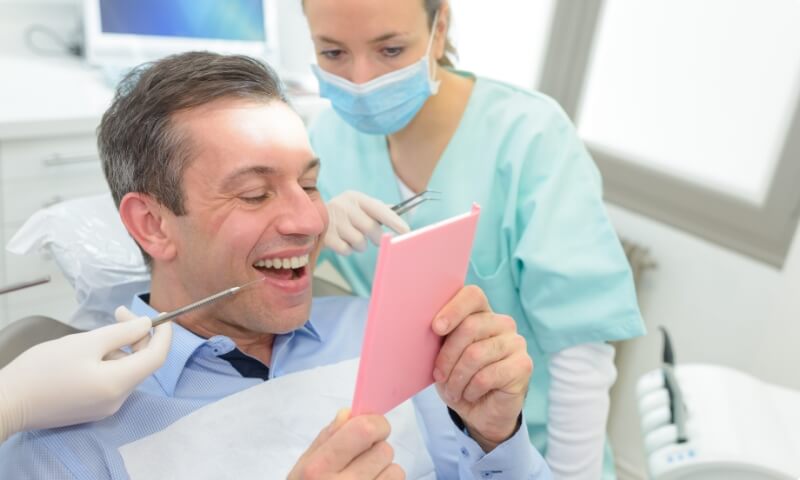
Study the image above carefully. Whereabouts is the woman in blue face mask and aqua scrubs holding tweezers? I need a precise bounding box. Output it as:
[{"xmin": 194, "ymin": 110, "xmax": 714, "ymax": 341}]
[{"xmin": 303, "ymin": 0, "xmax": 644, "ymax": 479}]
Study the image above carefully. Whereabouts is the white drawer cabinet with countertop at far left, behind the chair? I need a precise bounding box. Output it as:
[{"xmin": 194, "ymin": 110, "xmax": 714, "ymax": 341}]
[{"xmin": 0, "ymin": 56, "xmax": 112, "ymax": 328}]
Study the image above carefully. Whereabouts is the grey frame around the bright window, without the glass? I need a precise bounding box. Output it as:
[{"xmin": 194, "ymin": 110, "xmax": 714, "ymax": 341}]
[{"xmin": 538, "ymin": 0, "xmax": 800, "ymax": 269}]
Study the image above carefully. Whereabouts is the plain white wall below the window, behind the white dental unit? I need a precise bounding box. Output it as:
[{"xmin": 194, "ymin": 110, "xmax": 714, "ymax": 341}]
[{"xmin": 609, "ymin": 205, "xmax": 800, "ymax": 478}]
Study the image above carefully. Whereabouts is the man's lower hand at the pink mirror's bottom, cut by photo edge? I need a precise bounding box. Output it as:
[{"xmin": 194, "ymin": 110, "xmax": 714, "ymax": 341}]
[{"xmin": 287, "ymin": 409, "xmax": 406, "ymax": 480}]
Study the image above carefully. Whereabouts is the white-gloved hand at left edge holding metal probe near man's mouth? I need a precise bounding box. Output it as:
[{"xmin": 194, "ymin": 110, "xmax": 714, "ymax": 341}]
[{"xmin": 0, "ymin": 307, "xmax": 172, "ymax": 441}]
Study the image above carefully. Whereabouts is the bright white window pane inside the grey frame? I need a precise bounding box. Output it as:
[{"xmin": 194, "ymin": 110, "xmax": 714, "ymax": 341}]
[{"xmin": 578, "ymin": 0, "xmax": 800, "ymax": 205}]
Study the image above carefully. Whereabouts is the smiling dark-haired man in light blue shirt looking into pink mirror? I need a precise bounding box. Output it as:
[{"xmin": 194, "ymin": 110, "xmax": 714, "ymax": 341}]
[{"xmin": 0, "ymin": 53, "xmax": 549, "ymax": 479}]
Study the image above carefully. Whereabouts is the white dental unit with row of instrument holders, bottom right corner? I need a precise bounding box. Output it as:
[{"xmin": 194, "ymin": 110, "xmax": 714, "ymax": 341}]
[{"xmin": 636, "ymin": 329, "xmax": 800, "ymax": 480}]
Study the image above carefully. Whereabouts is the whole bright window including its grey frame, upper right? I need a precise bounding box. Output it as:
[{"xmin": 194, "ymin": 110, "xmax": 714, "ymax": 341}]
[{"xmin": 541, "ymin": 0, "xmax": 800, "ymax": 266}]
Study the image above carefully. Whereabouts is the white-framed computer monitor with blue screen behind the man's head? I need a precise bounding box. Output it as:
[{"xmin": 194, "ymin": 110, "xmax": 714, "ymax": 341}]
[{"xmin": 84, "ymin": 0, "xmax": 279, "ymax": 67}]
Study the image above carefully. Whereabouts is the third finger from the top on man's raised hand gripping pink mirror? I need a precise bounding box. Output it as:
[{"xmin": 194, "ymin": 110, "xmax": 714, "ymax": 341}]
[{"xmin": 444, "ymin": 334, "xmax": 521, "ymax": 403}]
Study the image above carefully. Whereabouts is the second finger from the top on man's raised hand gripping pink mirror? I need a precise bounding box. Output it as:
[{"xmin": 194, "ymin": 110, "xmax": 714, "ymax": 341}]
[{"xmin": 433, "ymin": 313, "xmax": 517, "ymax": 383}]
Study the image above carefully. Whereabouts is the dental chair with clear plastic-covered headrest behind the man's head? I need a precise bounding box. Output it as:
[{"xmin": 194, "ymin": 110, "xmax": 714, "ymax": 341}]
[{"xmin": 0, "ymin": 194, "xmax": 351, "ymax": 368}]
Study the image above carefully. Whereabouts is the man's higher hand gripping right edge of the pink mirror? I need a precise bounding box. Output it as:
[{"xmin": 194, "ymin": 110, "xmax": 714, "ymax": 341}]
[{"xmin": 433, "ymin": 286, "xmax": 533, "ymax": 452}]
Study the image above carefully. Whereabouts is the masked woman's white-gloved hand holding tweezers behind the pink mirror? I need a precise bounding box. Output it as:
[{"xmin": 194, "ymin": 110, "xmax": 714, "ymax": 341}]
[{"xmin": 325, "ymin": 190, "xmax": 410, "ymax": 255}]
